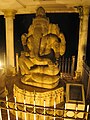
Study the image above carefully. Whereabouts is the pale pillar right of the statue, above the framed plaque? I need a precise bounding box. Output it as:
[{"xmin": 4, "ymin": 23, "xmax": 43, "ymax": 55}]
[{"xmin": 76, "ymin": 7, "xmax": 89, "ymax": 75}]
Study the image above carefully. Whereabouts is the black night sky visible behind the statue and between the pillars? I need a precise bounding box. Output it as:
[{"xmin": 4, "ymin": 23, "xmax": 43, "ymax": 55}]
[{"xmin": 0, "ymin": 13, "xmax": 90, "ymax": 66}]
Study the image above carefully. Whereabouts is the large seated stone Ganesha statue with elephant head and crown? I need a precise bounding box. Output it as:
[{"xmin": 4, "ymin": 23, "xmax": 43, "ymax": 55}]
[{"xmin": 19, "ymin": 7, "xmax": 66, "ymax": 89}]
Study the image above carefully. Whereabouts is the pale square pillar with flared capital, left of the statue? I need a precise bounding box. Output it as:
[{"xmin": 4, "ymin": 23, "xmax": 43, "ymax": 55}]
[{"xmin": 3, "ymin": 10, "xmax": 16, "ymax": 67}]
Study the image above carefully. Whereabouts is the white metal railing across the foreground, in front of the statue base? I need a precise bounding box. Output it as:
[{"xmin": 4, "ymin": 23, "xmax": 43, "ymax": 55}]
[{"xmin": 0, "ymin": 96, "xmax": 90, "ymax": 120}]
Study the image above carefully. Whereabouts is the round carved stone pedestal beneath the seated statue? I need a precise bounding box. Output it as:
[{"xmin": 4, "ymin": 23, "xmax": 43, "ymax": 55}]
[{"xmin": 11, "ymin": 80, "xmax": 64, "ymax": 120}]
